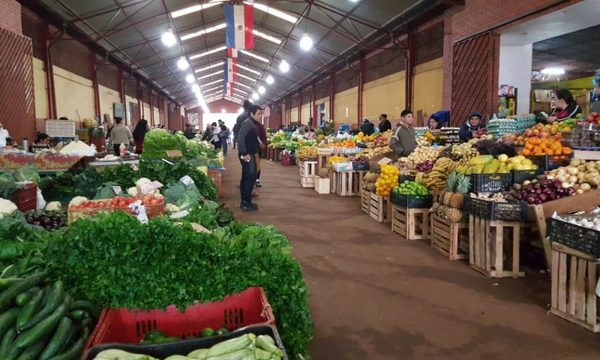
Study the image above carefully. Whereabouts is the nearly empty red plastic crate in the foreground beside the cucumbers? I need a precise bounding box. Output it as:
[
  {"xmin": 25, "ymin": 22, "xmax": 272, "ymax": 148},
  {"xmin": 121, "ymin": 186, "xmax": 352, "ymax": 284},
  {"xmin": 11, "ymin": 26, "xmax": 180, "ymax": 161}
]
[{"xmin": 86, "ymin": 287, "xmax": 275, "ymax": 349}]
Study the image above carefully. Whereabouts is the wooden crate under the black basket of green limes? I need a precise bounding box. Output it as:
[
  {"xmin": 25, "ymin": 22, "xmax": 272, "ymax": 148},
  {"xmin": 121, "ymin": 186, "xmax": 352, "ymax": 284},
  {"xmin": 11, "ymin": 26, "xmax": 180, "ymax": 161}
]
[{"xmin": 391, "ymin": 205, "xmax": 429, "ymax": 240}]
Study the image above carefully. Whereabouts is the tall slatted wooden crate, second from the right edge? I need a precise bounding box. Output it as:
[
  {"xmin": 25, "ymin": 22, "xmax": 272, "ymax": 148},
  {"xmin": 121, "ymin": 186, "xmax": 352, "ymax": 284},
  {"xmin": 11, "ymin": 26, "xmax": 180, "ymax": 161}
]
[{"xmin": 469, "ymin": 215, "xmax": 525, "ymax": 278}]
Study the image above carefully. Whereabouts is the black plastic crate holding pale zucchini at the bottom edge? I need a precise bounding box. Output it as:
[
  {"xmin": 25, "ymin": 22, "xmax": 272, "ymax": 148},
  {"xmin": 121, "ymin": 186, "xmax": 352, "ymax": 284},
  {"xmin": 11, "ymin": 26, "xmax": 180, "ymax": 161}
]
[{"xmin": 83, "ymin": 325, "xmax": 288, "ymax": 360}]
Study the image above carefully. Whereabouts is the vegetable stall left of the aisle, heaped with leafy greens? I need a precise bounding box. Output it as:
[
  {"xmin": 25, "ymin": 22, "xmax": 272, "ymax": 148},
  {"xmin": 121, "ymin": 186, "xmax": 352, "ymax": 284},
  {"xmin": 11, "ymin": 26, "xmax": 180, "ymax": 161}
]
[{"xmin": 0, "ymin": 130, "xmax": 312, "ymax": 360}]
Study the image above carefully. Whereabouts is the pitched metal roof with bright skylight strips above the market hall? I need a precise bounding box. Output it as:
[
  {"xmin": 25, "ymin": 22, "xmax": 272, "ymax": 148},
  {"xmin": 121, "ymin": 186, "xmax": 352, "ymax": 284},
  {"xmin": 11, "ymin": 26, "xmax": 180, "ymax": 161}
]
[{"xmin": 34, "ymin": 0, "xmax": 448, "ymax": 107}]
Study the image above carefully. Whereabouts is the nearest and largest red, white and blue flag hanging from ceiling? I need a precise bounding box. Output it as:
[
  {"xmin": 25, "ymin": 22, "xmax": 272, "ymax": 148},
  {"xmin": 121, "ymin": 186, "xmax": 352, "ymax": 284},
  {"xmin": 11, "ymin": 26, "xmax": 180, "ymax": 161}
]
[{"xmin": 225, "ymin": 4, "xmax": 254, "ymax": 49}]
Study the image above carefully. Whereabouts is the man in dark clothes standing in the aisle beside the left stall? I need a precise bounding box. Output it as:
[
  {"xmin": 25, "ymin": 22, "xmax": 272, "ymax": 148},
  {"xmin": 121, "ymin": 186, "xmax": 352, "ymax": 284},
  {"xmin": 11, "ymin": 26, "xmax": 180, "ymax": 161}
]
[{"xmin": 237, "ymin": 105, "xmax": 262, "ymax": 211}]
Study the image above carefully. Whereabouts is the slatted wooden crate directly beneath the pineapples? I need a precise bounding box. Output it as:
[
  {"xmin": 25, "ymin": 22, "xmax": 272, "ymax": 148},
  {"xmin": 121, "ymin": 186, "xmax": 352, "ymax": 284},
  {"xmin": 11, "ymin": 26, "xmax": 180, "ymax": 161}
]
[{"xmin": 429, "ymin": 214, "xmax": 469, "ymax": 260}]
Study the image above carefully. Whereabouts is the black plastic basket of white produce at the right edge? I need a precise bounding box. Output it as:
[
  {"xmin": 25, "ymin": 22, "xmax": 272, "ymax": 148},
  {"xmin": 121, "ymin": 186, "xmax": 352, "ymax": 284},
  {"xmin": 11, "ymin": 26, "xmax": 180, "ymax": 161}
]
[{"xmin": 547, "ymin": 218, "xmax": 600, "ymax": 258}]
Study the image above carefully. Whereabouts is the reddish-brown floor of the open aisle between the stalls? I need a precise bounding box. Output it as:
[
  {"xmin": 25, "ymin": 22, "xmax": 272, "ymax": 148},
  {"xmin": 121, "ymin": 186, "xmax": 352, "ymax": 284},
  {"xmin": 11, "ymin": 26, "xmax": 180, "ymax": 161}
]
[{"xmin": 223, "ymin": 152, "xmax": 600, "ymax": 360}]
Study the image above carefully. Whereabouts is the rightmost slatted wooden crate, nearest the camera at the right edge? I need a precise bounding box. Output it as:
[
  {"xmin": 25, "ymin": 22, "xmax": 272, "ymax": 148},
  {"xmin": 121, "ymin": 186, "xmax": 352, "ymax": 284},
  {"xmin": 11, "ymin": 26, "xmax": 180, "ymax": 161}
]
[{"xmin": 550, "ymin": 243, "xmax": 600, "ymax": 333}]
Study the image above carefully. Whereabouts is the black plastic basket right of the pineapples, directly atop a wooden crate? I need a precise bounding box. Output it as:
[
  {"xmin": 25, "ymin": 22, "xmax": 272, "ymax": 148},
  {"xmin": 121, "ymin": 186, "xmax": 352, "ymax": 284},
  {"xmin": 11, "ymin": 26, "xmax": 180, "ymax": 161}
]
[{"xmin": 466, "ymin": 197, "xmax": 527, "ymax": 221}]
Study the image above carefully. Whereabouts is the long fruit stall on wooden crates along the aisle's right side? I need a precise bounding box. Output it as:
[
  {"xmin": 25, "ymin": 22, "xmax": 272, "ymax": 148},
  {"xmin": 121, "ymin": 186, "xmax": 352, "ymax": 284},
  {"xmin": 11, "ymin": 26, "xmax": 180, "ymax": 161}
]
[{"xmin": 286, "ymin": 114, "xmax": 600, "ymax": 332}]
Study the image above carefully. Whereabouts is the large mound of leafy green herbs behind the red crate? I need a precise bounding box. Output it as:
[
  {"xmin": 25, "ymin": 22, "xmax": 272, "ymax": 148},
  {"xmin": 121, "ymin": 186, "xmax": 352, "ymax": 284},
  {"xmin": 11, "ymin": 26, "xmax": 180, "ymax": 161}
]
[{"xmin": 46, "ymin": 210, "xmax": 312, "ymax": 358}]
